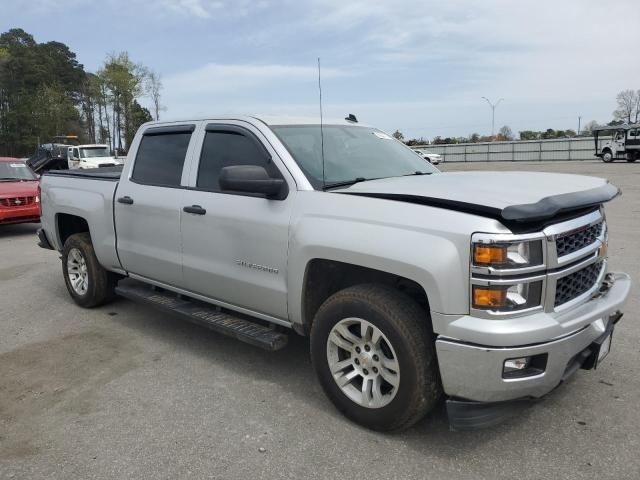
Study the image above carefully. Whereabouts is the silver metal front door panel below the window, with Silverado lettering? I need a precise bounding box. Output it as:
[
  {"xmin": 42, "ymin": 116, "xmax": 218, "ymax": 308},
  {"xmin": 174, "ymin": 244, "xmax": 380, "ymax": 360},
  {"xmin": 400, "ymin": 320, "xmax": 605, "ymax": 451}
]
[{"xmin": 181, "ymin": 190, "xmax": 293, "ymax": 319}]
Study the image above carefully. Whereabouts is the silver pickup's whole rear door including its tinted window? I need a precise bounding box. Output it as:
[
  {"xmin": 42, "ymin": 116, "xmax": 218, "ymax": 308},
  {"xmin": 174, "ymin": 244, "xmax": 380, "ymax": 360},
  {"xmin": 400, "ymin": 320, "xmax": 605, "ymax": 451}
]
[{"xmin": 114, "ymin": 125, "xmax": 195, "ymax": 287}]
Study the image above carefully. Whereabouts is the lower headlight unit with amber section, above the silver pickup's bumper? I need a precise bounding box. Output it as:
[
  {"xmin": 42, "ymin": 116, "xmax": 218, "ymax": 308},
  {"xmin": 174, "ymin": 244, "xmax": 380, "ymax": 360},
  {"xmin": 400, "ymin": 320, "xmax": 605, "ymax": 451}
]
[{"xmin": 472, "ymin": 280, "xmax": 542, "ymax": 312}]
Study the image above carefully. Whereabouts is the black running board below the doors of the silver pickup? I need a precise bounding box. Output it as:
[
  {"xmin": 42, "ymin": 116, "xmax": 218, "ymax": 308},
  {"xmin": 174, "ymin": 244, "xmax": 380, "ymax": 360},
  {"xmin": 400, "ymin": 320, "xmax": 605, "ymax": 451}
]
[{"xmin": 115, "ymin": 282, "xmax": 289, "ymax": 351}]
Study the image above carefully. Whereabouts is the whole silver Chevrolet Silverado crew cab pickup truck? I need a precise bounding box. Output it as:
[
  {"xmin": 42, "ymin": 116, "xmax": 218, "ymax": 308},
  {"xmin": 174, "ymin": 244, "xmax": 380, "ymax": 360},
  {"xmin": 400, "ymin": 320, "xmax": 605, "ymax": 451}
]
[{"xmin": 38, "ymin": 117, "xmax": 631, "ymax": 430}]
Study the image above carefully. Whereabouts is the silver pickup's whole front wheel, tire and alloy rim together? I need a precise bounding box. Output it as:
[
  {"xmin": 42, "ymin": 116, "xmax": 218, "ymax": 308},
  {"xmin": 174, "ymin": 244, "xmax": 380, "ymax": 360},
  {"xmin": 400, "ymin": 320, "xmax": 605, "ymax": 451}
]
[{"xmin": 311, "ymin": 285, "xmax": 441, "ymax": 431}]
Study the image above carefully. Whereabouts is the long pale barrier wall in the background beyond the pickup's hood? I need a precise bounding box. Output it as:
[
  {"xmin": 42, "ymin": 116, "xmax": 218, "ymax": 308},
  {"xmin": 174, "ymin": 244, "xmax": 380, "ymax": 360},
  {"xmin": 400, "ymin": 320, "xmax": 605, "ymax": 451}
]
[{"xmin": 412, "ymin": 137, "xmax": 610, "ymax": 162}]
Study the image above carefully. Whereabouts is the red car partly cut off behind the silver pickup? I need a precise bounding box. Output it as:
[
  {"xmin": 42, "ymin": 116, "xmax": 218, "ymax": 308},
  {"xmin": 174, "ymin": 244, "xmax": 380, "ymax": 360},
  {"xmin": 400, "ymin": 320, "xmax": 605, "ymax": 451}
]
[{"xmin": 0, "ymin": 157, "xmax": 40, "ymax": 225}]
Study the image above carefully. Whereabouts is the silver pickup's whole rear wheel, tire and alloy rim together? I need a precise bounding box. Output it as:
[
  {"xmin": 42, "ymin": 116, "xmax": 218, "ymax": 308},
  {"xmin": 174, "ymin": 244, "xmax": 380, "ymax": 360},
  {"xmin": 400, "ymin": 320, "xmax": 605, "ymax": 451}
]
[{"xmin": 62, "ymin": 233, "xmax": 117, "ymax": 308}]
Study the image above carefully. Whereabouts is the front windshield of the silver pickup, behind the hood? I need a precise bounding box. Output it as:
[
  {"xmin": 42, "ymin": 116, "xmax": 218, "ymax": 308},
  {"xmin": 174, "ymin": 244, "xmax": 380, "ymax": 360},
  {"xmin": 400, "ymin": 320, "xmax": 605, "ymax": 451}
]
[{"xmin": 271, "ymin": 125, "xmax": 438, "ymax": 189}]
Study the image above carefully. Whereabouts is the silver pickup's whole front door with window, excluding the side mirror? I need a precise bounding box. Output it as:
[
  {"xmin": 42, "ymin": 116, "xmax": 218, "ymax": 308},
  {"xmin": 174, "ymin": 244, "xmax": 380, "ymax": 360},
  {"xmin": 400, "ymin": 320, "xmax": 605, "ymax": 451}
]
[{"xmin": 181, "ymin": 122, "xmax": 296, "ymax": 319}]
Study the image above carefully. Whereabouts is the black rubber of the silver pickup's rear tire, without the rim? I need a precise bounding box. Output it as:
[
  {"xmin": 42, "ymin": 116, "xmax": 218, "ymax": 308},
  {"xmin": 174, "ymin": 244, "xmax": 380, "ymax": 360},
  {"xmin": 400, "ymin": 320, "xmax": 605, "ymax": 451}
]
[{"xmin": 62, "ymin": 233, "xmax": 117, "ymax": 308}]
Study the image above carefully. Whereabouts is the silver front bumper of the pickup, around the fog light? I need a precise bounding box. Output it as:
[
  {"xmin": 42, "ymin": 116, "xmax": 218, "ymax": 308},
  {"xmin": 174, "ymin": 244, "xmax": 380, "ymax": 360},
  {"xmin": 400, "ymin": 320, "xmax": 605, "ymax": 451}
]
[{"xmin": 436, "ymin": 273, "xmax": 631, "ymax": 402}]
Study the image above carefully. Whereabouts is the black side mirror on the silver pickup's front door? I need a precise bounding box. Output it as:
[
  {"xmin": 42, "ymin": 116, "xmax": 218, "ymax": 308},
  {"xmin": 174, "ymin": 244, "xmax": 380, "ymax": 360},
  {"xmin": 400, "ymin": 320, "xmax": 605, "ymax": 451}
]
[{"xmin": 219, "ymin": 165, "xmax": 288, "ymax": 200}]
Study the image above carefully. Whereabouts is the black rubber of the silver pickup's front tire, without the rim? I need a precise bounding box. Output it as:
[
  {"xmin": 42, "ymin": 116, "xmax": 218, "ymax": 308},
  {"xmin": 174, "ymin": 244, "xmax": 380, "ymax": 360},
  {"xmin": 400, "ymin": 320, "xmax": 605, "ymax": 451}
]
[{"xmin": 311, "ymin": 285, "xmax": 442, "ymax": 431}]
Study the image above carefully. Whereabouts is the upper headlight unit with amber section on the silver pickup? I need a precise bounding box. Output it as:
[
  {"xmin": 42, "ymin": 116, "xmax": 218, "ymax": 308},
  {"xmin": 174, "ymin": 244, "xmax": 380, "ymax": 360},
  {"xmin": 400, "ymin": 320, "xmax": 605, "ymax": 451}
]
[{"xmin": 473, "ymin": 240, "xmax": 542, "ymax": 270}]
